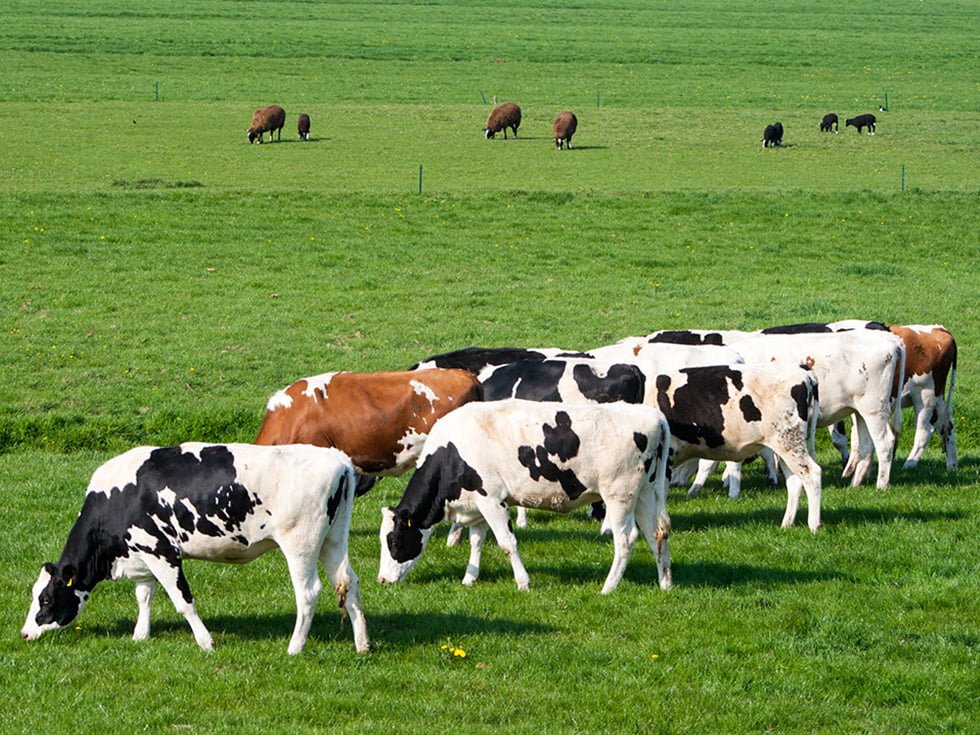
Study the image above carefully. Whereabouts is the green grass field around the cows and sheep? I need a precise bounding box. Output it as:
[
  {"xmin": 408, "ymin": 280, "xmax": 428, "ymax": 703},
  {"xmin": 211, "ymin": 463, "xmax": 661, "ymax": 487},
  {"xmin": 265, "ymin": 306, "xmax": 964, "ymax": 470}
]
[{"xmin": 0, "ymin": 0, "xmax": 980, "ymax": 733}]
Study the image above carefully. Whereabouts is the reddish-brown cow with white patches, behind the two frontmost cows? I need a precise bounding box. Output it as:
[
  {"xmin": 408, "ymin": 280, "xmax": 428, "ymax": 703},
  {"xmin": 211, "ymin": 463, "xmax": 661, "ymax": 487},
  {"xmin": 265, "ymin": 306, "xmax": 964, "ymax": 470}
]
[{"xmin": 255, "ymin": 369, "xmax": 483, "ymax": 495}]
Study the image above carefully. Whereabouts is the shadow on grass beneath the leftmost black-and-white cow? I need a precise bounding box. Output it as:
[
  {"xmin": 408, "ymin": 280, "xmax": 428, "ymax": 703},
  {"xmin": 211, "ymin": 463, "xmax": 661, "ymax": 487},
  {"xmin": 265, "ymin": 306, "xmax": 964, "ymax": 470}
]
[{"xmin": 105, "ymin": 608, "xmax": 558, "ymax": 654}]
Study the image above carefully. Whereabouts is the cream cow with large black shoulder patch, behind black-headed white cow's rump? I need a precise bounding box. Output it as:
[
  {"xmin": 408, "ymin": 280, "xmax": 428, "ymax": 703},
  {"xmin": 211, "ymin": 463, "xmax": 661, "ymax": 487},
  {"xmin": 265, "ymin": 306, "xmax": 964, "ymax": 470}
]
[{"xmin": 647, "ymin": 364, "xmax": 823, "ymax": 533}]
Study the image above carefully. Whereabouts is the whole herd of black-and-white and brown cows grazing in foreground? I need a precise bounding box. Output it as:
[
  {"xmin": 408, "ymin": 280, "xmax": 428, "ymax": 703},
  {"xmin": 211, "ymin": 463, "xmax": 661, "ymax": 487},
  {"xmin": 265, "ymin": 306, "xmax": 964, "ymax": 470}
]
[{"xmin": 21, "ymin": 320, "xmax": 957, "ymax": 654}]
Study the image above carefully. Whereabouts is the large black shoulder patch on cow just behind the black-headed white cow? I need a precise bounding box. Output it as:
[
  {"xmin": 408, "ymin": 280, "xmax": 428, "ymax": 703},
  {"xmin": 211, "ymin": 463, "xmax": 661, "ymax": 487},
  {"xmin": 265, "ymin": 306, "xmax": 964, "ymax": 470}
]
[{"xmin": 656, "ymin": 365, "xmax": 742, "ymax": 447}]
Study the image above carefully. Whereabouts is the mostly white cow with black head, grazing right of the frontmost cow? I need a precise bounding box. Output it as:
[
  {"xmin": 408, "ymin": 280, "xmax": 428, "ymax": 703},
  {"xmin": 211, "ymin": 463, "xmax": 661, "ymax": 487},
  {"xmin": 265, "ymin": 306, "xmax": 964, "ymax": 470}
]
[{"xmin": 378, "ymin": 399, "xmax": 671, "ymax": 594}]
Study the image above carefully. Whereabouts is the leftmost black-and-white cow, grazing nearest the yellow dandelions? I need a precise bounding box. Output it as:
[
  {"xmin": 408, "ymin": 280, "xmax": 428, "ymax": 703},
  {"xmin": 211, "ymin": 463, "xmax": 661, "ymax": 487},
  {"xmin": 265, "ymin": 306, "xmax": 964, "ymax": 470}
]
[{"xmin": 21, "ymin": 443, "xmax": 369, "ymax": 654}]
